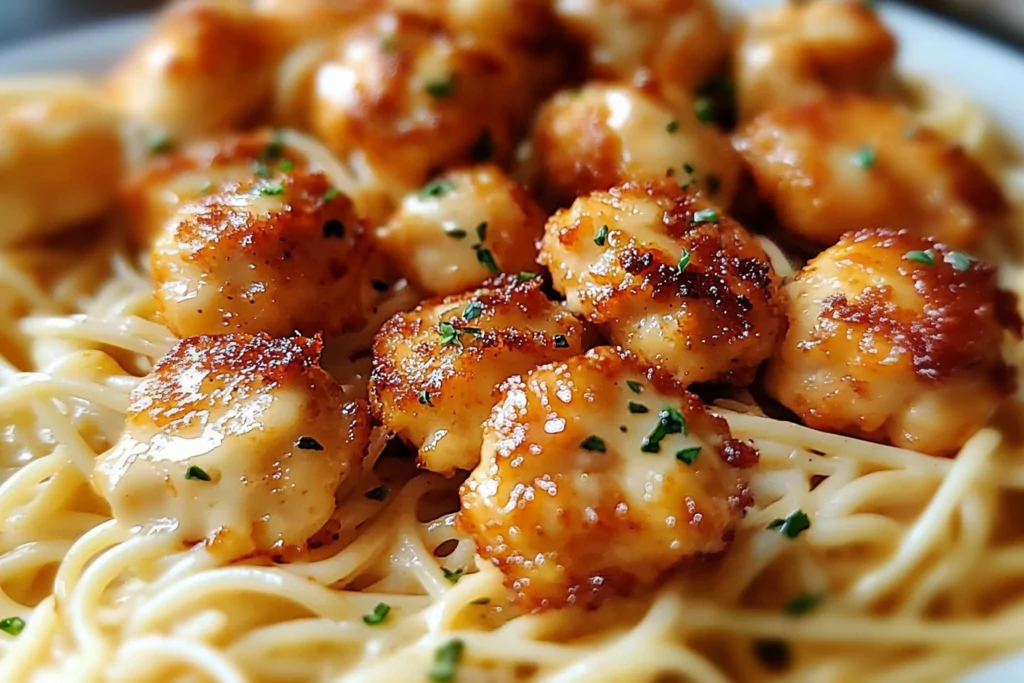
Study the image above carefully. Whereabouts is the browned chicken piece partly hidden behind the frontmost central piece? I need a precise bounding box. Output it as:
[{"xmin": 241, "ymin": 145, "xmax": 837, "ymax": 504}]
[{"xmin": 370, "ymin": 275, "xmax": 591, "ymax": 474}]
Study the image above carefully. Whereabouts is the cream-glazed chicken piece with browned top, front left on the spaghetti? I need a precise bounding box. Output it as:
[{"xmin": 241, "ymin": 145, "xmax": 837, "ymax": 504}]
[{"xmin": 93, "ymin": 335, "xmax": 370, "ymax": 557}]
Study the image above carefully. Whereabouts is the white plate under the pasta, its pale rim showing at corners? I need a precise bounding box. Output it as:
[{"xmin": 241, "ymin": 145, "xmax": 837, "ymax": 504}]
[{"xmin": 0, "ymin": 0, "xmax": 1024, "ymax": 683}]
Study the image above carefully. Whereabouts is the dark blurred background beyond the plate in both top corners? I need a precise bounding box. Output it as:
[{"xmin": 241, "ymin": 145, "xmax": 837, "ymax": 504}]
[{"xmin": 0, "ymin": 0, "xmax": 1024, "ymax": 50}]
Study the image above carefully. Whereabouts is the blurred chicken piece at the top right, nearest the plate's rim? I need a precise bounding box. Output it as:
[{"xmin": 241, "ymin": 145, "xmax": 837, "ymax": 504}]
[{"xmin": 733, "ymin": 0, "xmax": 896, "ymax": 121}]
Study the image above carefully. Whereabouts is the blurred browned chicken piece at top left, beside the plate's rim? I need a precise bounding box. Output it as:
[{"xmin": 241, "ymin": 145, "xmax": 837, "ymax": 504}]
[{"xmin": 106, "ymin": 0, "xmax": 287, "ymax": 141}]
